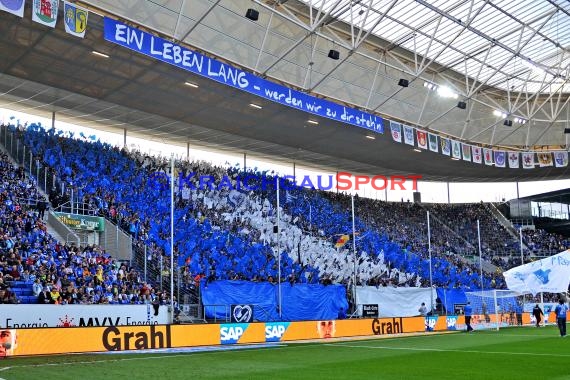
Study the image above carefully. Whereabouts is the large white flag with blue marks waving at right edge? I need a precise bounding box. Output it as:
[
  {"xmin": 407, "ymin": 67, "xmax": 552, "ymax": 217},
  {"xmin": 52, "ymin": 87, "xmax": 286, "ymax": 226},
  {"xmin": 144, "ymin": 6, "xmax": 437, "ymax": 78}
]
[{"xmin": 503, "ymin": 250, "xmax": 570, "ymax": 295}]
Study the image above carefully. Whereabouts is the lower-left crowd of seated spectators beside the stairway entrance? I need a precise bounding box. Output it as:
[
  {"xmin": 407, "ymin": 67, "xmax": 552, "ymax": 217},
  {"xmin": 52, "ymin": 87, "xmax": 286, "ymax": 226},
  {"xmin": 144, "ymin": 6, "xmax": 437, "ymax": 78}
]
[{"xmin": 0, "ymin": 145, "xmax": 168, "ymax": 304}]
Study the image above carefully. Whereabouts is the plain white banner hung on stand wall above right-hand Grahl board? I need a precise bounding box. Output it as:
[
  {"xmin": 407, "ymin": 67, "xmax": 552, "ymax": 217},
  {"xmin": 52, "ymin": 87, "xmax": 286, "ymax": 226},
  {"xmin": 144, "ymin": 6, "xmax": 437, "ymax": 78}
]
[{"xmin": 356, "ymin": 286, "xmax": 437, "ymax": 318}]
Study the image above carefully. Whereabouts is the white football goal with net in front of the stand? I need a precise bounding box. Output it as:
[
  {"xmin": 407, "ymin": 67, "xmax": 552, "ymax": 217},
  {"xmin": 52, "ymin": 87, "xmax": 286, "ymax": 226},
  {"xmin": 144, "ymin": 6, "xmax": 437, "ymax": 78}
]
[{"xmin": 465, "ymin": 289, "xmax": 531, "ymax": 330}]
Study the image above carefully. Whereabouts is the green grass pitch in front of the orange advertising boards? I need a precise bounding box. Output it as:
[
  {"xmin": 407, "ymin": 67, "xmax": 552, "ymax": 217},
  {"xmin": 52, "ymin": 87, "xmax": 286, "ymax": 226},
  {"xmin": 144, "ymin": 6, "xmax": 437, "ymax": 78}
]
[{"xmin": 0, "ymin": 326, "xmax": 570, "ymax": 380}]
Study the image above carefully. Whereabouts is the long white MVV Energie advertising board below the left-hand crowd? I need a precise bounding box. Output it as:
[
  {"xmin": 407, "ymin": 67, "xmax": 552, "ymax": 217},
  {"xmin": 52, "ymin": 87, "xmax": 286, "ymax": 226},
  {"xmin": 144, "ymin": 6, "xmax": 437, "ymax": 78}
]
[{"xmin": 0, "ymin": 304, "xmax": 170, "ymax": 329}]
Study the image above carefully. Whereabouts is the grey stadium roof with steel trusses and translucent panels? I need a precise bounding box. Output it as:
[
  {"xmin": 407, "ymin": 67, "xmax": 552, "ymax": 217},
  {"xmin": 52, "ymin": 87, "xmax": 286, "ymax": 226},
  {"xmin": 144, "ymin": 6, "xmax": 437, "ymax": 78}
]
[{"xmin": 0, "ymin": 0, "xmax": 570, "ymax": 181}]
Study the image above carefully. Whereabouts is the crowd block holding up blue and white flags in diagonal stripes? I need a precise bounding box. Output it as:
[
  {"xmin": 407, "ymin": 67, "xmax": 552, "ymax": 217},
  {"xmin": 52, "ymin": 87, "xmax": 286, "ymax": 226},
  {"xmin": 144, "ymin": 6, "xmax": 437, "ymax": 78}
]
[{"xmin": 24, "ymin": 126, "xmax": 493, "ymax": 288}]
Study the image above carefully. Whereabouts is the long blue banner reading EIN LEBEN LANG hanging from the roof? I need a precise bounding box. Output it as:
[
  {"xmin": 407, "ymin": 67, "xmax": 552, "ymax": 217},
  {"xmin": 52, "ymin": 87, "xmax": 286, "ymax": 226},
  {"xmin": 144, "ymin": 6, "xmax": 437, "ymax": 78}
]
[{"xmin": 105, "ymin": 17, "xmax": 384, "ymax": 133}]
